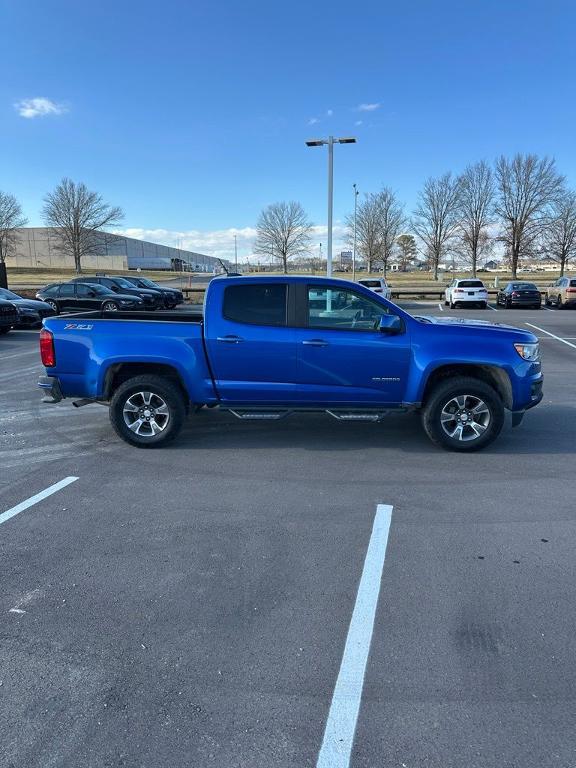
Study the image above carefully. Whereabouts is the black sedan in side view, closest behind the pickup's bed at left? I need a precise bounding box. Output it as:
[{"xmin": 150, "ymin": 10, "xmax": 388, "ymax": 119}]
[{"xmin": 36, "ymin": 282, "xmax": 145, "ymax": 314}]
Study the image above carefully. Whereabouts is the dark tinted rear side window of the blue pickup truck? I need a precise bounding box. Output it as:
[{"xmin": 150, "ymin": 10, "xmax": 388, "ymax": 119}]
[{"xmin": 222, "ymin": 283, "xmax": 287, "ymax": 326}]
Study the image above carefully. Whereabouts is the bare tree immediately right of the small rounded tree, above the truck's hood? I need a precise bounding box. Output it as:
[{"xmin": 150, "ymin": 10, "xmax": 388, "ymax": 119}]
[{"xmin": 412, "ymin": 173, "xmax": 460, "ymax": 280}]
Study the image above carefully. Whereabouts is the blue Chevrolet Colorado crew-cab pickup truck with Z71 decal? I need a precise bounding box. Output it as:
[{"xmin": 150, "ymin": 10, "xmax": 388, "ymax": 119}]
[{"xmin": 39, "ymin": 276, "xmax": 542, "ymax": 451}]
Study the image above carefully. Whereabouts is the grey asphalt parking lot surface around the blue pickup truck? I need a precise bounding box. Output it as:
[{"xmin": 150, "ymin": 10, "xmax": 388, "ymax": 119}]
[{"xmin": 0, "ymin": 304, "xmax": 576, "ymax": 768}]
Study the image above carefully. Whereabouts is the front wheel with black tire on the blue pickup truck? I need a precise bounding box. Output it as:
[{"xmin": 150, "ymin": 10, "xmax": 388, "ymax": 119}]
[{"xmin": 422, "ymin": 376, "xmax": 504, "ymax": 452}]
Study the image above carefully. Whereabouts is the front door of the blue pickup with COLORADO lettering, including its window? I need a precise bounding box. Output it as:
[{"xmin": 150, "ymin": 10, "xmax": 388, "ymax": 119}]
[{"xmin": 297, "ymin": 285, "xmax": 410, "ymax": 407}]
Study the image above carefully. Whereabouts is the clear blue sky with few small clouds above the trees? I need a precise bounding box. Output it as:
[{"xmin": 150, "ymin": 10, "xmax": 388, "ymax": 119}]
[{"xmin": 0, "ymin": 0, "xmax": 576, "ymax": 257}]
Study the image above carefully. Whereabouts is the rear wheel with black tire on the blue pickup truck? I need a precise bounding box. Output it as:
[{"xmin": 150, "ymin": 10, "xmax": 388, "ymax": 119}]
[{"xmin": 110, "ymin": 374, "xmax": 186, "ymax": 448}]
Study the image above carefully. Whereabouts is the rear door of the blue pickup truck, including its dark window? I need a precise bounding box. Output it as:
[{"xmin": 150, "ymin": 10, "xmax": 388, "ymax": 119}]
[{"xmin": 205, "ymin": 278, "xmax": 298, "ymax": 405}]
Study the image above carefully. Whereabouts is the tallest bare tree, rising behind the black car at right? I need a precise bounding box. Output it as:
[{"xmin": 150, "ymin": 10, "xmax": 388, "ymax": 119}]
[{"xmin": 495, "ymin": 154, "xmax": 564, "ymax": 278}]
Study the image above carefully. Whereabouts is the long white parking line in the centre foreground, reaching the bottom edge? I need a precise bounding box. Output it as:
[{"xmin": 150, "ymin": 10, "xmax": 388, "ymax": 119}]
[{"xmin": 316, "ymin": 504, "xmax": 393, "ymax": 768}]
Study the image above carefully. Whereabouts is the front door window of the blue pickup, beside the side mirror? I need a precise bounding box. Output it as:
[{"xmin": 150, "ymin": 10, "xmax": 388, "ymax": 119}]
[{"xmin": 308, "ymin": 285, "xmax": 389, "ymax": 331}]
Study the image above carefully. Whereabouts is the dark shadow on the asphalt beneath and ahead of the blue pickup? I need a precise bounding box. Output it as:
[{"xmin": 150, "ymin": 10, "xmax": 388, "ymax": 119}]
[{"xmin": 169, "ymin": 405, "xmax": 576, "ymax": 456}]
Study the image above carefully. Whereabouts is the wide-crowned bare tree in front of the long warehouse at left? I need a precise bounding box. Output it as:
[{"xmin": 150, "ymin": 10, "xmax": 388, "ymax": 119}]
[{"xmin": 42, "ymin": 179, "xmax": 124, "ymax": 273}]
